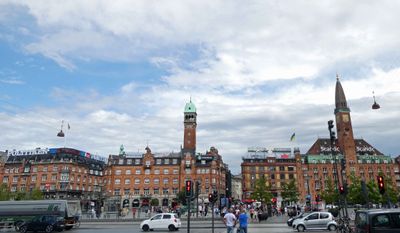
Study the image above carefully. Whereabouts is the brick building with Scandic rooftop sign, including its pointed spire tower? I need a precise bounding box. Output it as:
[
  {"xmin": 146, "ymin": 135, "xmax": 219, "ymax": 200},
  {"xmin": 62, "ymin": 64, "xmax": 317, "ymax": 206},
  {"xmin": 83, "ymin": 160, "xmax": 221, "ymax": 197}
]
[{"xmin": 297, "ymin": 78, "xmax": 398, "ymax": 201}]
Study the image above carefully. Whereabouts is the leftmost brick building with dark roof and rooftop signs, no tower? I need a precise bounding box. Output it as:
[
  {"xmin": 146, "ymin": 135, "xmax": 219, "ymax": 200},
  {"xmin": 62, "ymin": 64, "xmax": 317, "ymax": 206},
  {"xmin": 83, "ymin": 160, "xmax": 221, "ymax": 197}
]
[{"xmin": 0, "ymin": 148, "xmax": 105, "ymax": 209}]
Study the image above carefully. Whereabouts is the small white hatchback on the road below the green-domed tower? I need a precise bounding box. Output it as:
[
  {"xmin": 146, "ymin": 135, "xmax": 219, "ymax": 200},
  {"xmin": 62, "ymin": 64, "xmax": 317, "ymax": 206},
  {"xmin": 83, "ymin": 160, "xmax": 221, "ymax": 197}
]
[{"xmin": 140, "ymin": 213, "xmax": 181, "ymax": 231}]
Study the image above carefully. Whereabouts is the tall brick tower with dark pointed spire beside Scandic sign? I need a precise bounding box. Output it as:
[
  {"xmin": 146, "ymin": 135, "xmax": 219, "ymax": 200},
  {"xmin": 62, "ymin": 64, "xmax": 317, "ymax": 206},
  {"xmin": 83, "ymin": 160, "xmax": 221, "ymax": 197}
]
[{"xmin": 335, "ymin": 76, "xmax": 357, "ymax": 163}]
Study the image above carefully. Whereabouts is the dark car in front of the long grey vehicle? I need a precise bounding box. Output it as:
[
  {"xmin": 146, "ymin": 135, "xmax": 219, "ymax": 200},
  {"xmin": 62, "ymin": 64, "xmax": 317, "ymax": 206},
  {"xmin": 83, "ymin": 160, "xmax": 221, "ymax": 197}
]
[{"xmin": 16, "ymin": 215, "xmax": 65, "ymax": 233}]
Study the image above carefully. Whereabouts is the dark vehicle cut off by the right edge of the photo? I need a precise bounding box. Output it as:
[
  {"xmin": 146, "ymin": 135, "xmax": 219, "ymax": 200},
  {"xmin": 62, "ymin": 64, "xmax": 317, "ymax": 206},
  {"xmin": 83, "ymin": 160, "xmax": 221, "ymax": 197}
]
[{"xmin": 354, "ymin": 209, "xmax": 400, "ymax": 233}]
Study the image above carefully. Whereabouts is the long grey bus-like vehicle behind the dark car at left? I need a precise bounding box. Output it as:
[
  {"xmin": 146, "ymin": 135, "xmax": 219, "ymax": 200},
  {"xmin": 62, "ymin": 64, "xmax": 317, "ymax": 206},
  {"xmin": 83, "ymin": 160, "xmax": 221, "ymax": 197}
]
[{"xmin": 0, "ymin": 200, "xmax": 82, "ymax": 230}]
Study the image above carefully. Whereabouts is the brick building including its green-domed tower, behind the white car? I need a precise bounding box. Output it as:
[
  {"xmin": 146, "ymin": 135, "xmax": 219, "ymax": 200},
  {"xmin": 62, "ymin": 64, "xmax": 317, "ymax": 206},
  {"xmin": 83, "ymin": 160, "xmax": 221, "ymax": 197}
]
[{"xmin": 101, "ymin": 101, "xmax": 229, "ymax": 208}]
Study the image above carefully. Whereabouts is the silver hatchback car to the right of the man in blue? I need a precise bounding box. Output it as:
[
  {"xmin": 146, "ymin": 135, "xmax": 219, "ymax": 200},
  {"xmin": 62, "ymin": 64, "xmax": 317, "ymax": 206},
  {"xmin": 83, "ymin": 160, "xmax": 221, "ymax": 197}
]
[{"xmin": 292, "ymin": 212, "xmax": 337, "ymax": 232}]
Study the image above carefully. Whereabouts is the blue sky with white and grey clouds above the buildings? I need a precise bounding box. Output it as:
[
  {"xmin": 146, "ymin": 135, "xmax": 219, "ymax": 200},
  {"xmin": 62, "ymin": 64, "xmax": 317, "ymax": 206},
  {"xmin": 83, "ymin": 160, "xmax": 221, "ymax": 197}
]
[{"xmin": 0, "ymin": 0, "xmax": 400, "ymax": 173}]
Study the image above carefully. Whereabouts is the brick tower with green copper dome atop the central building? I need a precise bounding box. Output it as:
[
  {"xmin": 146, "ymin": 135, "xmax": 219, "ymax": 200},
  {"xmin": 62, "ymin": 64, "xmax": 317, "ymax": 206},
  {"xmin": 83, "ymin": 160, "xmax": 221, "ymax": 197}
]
[{"xmin": 183, "ymin": 100, "xmax": 197, "ymax": 155}]
